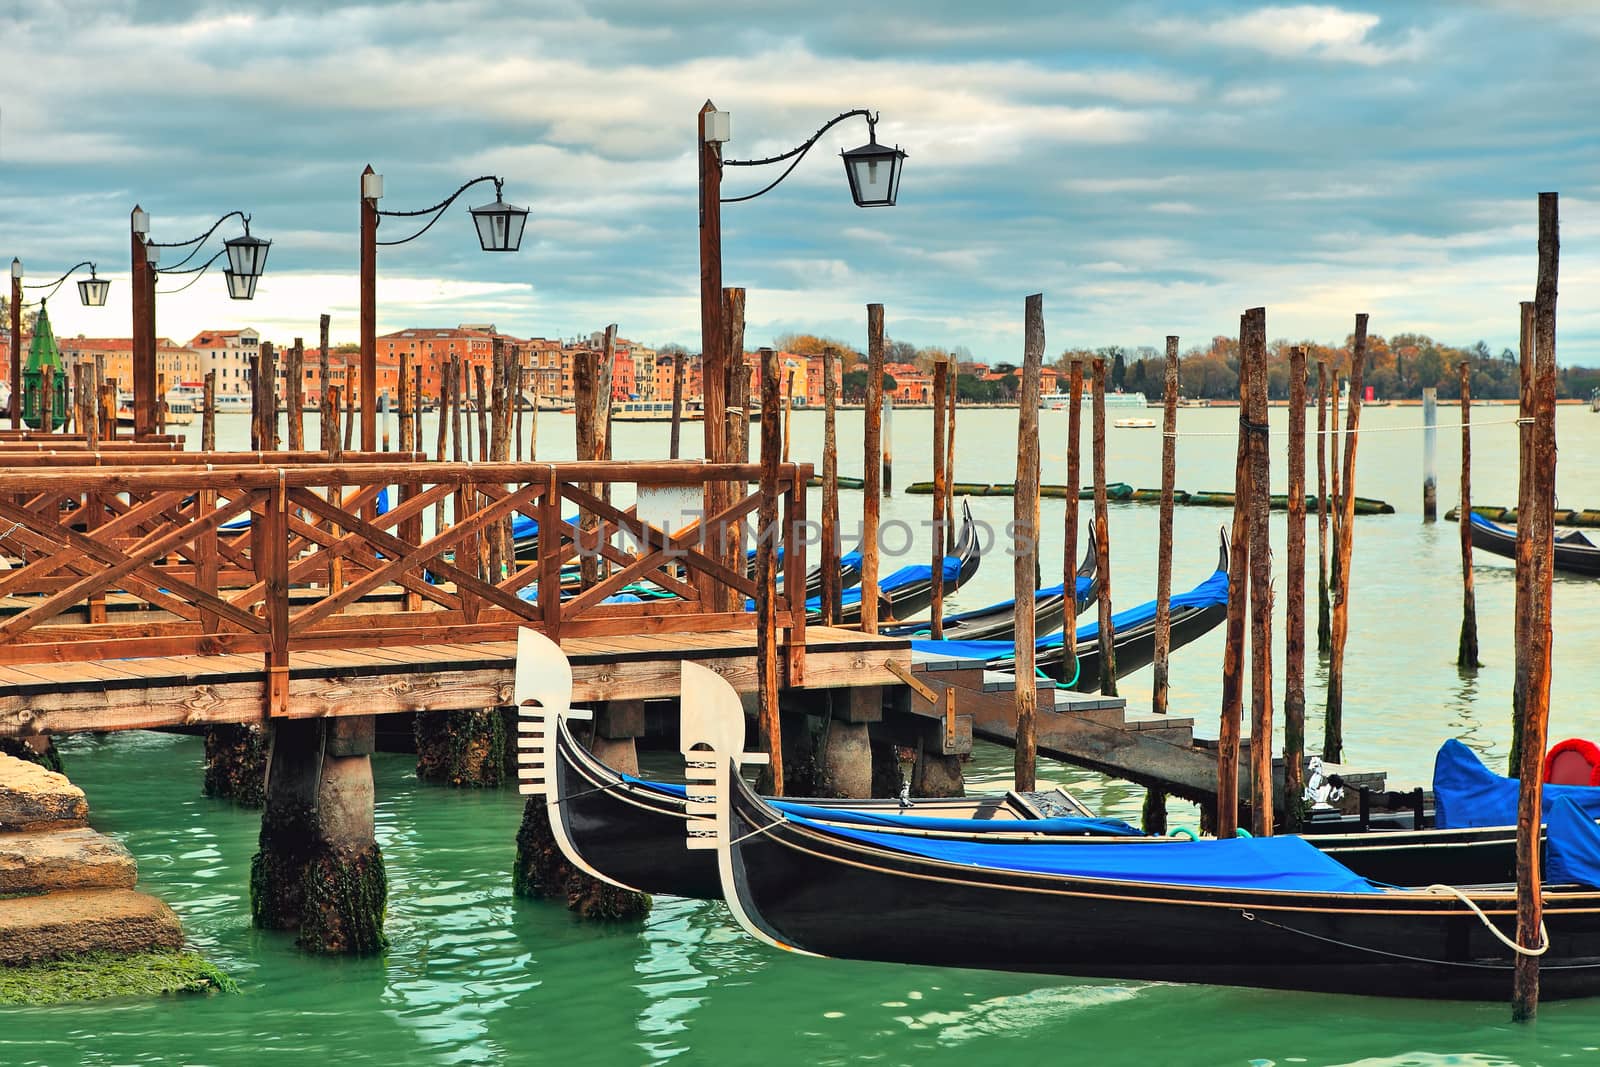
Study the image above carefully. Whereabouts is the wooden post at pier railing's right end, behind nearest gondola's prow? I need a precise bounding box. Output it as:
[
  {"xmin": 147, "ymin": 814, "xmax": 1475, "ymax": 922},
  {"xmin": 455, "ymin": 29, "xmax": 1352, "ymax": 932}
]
[{"xmin": 758, "ymin": 349, "xmax": 790, "ymax": 797}]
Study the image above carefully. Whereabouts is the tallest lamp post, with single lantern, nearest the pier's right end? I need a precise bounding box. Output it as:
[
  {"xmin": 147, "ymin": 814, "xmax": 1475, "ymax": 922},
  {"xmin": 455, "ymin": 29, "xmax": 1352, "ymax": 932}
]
[{"xmin": 699, "ymin": 101, "xmax": 906, "ymax": 462}]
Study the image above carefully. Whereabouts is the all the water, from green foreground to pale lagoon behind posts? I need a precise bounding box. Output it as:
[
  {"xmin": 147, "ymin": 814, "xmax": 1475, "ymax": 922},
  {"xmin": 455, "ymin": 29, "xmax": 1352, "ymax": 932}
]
[{"xmin": 0, "ymin": 408, "xmax": 1600, "ymax": 1067}]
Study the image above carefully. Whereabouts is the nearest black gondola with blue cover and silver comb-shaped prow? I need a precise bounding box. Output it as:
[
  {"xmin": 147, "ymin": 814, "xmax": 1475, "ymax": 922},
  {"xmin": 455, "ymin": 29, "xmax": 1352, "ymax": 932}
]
[{"xmin": 704, "ymin": 735, "xmax": 1600, "ymax": 1000}]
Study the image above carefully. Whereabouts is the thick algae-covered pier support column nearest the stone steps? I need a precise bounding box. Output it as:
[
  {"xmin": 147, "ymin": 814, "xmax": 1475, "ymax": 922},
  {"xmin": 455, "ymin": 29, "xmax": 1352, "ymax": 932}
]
[{"xmin": 250, "ymin": 715, "xmax": 389, "ymax": 955}]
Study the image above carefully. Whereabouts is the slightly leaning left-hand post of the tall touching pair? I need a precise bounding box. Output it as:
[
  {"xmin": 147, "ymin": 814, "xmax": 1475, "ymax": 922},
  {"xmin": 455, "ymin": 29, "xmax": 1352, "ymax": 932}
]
[{"xmin": 1216, "ymin": 312, "xmax": 1253, "ymax": 838}]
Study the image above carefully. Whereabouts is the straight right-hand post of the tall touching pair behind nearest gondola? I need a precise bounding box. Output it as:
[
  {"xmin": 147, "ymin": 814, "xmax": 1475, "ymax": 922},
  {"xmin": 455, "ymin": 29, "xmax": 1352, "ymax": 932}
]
[{"xmin": 1246, "ymin": 307, "xmax": 1272, "ymax": 837}]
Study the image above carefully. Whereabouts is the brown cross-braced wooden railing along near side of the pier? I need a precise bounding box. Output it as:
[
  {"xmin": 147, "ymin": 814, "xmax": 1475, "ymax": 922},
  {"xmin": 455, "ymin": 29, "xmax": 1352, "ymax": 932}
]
[{"xmin": 0, "ymin": 462, "xmax": 811, "ymax": 713}]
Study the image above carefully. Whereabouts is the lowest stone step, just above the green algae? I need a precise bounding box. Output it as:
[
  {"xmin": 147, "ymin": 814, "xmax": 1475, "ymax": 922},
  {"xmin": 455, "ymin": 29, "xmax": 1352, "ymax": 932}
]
[{"xmin": 0, "ymin": 889, "xmax": 184, "ymax": 963}]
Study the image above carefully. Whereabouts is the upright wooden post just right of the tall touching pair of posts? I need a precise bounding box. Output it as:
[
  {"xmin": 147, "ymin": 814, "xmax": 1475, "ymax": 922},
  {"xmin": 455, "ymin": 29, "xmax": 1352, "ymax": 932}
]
[{"xmin": 1283, "ymin": 346, "xmax": 1322, "ymax": 833}]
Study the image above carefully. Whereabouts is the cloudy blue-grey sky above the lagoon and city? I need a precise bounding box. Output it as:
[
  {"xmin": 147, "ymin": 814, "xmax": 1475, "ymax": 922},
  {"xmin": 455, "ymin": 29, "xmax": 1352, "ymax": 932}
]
[{"xmin": 0, "ymin": 0, "xmax": 1600, "ymax": 363}]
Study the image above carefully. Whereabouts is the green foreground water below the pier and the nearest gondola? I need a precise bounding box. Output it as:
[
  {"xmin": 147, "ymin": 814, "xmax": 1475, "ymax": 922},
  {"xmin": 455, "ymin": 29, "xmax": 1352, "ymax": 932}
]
[{"xmin": 9, "ymin": 734, "xmax": 1600, "ymax": 1067}]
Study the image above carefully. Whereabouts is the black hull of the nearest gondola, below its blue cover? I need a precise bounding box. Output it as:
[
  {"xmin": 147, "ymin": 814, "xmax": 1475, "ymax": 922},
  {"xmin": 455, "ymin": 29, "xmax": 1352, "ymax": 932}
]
[{"xmin": 718, "ymin": 771, "xmax": 1600, "ymax": 1000}]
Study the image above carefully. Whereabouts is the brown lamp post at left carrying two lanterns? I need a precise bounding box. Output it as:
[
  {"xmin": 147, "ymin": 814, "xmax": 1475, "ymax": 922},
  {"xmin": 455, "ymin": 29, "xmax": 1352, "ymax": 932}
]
[{"xmin": 134, "ymin": 205, "xmax": 272, "ymax": 438}]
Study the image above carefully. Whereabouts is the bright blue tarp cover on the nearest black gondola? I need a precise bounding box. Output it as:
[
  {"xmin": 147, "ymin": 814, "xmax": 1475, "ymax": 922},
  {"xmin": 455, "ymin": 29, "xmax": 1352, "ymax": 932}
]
[{"xmin": 797, "ymin": 819, "xmax": 1379, "ymax": 893}]
